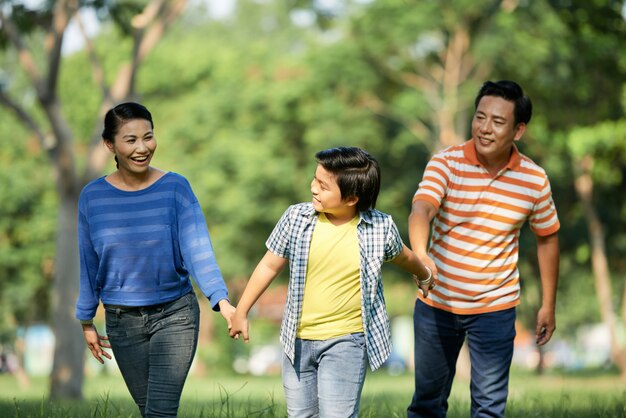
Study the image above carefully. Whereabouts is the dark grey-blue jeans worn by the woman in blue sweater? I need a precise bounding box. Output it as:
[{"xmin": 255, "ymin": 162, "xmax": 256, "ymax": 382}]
[{"xmin": 105, "ymin": 292, "xmax": 200, "ymax": 417}]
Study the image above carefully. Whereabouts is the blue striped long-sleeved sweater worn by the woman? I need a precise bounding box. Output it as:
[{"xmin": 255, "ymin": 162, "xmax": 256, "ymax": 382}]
[{"xmin": 76, "ymin": 172, "xmax": 228, "ymax": 319}]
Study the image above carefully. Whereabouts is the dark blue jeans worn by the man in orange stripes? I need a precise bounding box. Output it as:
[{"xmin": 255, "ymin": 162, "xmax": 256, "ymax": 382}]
[{"xmin": 408, "ymin": 299, "xmax": 515, "ymax": 418}]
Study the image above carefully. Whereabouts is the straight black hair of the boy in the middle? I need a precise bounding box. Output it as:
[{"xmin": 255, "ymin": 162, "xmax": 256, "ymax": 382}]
[{"xmin": 315, "ymin": 147, "xmax": 380, "ymax": 211}]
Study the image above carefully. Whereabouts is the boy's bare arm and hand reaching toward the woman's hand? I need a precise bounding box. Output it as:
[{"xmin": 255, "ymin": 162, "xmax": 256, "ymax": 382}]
[{"xmin": 229, "ymin": 251, "xmax": 288, "ymax": 342}]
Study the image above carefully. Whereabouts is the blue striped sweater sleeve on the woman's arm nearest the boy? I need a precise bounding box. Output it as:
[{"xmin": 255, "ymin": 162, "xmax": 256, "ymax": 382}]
[{"xmin": 178, "ymin": 183, "xmax": 228, "ymax": 311}]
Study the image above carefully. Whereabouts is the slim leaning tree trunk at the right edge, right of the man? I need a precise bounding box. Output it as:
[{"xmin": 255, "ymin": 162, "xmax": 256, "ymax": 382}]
[{"xmin": 574, "ymin": 156, "xmax": 626, "ymax": 379}]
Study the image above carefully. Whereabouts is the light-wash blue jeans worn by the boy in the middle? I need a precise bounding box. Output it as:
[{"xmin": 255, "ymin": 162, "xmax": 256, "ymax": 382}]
[{"xmin": 283, "ymin": 333, "xmax": 367, "ymax": 418}]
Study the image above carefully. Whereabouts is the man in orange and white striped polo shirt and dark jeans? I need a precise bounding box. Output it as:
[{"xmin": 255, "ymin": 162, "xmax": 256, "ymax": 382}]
[{"xmin": 408, "ymin": 81, "xmax": 560, "ymax": 417}]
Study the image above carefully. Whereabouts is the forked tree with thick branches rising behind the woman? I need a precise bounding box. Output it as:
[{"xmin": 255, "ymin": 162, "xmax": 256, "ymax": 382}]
[{"xmin": 0, "ymin": 0, "xmax": 186, "ymax": 398}]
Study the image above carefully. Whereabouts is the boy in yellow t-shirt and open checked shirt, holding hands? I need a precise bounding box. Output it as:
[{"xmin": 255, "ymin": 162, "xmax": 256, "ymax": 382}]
[{"xmin": 230, "ymin": 147, "xmax": 434, "ymax": 417}]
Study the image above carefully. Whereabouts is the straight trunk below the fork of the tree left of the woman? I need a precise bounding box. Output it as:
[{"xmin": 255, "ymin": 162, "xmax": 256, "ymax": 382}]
[{"xmin": 50, "ymin": 191, "xmax": 85, "ymax": 399}]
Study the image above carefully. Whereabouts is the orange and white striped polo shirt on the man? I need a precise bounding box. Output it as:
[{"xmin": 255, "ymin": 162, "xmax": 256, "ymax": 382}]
[{"xmin": 413, "ymin": 140, "xmax": 560, "ymax": 314}]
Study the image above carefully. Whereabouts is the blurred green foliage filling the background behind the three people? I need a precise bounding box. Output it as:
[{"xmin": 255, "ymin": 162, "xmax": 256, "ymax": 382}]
[{"xmin": 0, "ymin": 0, "xmax": 626, "ymax": 364}]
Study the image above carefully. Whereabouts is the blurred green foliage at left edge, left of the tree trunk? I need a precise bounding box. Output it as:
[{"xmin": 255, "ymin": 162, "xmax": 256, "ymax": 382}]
[{"xmin": 0, "ymin": 113, "xmax": 56, "ymax": 344}]
